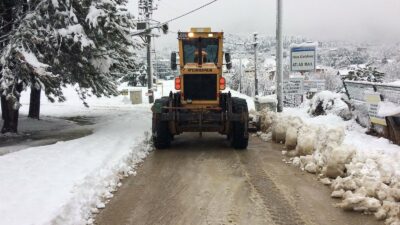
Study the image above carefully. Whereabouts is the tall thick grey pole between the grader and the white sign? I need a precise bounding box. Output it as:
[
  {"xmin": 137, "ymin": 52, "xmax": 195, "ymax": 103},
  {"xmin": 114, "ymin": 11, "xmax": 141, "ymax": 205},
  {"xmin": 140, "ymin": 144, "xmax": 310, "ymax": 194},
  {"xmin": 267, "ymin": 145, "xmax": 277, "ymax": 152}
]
[{"xmin": 276, "ymin": 0, "xmax": 283, "ymax": 112}]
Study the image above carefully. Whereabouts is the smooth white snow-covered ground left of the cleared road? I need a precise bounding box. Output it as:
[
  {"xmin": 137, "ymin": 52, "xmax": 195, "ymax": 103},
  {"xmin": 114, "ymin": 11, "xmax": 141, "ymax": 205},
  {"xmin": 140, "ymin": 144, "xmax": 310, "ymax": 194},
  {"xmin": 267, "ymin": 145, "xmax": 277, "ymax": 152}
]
[{"xmin": 0, "ymin": 82, "xmax": 172, "ymax": 225}]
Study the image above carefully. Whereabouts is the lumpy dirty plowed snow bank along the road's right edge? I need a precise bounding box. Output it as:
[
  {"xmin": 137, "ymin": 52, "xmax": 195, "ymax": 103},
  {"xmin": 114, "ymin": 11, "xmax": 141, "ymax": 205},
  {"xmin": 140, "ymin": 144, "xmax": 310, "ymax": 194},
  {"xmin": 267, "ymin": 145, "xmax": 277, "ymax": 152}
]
[{"xmin": 259, "ymin": 90, "xmax": 400, "ymax": 225}]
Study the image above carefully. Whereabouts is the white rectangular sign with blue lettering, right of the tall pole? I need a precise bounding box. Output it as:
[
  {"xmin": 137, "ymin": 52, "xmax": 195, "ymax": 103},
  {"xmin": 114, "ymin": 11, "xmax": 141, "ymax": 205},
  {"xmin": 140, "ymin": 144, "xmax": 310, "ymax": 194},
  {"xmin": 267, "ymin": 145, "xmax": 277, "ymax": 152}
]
[{"xmin": 290, "ymin": 47, "xmax": 316, "ymax": 72}]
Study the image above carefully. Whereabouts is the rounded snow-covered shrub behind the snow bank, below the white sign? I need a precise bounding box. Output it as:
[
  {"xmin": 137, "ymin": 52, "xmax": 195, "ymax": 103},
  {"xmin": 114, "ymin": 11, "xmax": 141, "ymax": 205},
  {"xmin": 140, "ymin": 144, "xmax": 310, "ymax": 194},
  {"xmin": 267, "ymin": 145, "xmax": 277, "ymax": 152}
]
[{"xmin": 309, "ymin": 91, "xmax": 352, "ymax": 120}]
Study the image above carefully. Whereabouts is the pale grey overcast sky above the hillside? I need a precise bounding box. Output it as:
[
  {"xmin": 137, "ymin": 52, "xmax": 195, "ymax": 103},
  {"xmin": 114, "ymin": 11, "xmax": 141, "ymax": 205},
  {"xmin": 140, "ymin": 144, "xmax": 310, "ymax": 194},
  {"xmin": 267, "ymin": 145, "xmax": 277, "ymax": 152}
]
[{"xmin": 129, "ymin": 0, "xmax": 400, "ymax": 45}]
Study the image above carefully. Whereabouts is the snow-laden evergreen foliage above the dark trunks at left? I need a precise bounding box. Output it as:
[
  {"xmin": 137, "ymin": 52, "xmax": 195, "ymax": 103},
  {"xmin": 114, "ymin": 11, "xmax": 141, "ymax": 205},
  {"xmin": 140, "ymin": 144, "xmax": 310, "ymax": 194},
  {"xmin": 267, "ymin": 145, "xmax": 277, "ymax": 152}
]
[{"xmin": 0, "ymin": 0, "xmax": 142, "ymax": 133}]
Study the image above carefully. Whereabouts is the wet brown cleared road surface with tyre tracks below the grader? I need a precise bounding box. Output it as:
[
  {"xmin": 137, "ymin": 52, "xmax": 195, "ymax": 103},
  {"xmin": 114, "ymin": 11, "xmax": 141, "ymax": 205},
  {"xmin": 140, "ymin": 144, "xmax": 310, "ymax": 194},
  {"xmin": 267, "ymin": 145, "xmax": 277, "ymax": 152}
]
[{"xmin": 95, "ymin": 134, "xmax": 380, "ymax": 225}]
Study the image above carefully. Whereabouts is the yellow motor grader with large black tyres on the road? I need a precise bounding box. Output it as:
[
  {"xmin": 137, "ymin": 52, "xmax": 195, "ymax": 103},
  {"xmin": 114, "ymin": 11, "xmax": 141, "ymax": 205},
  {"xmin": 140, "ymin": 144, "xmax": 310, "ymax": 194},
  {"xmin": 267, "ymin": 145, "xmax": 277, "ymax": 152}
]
[{"xmin": 152, "ymin": 28, "xmax": 249, "ymax": 149}]
